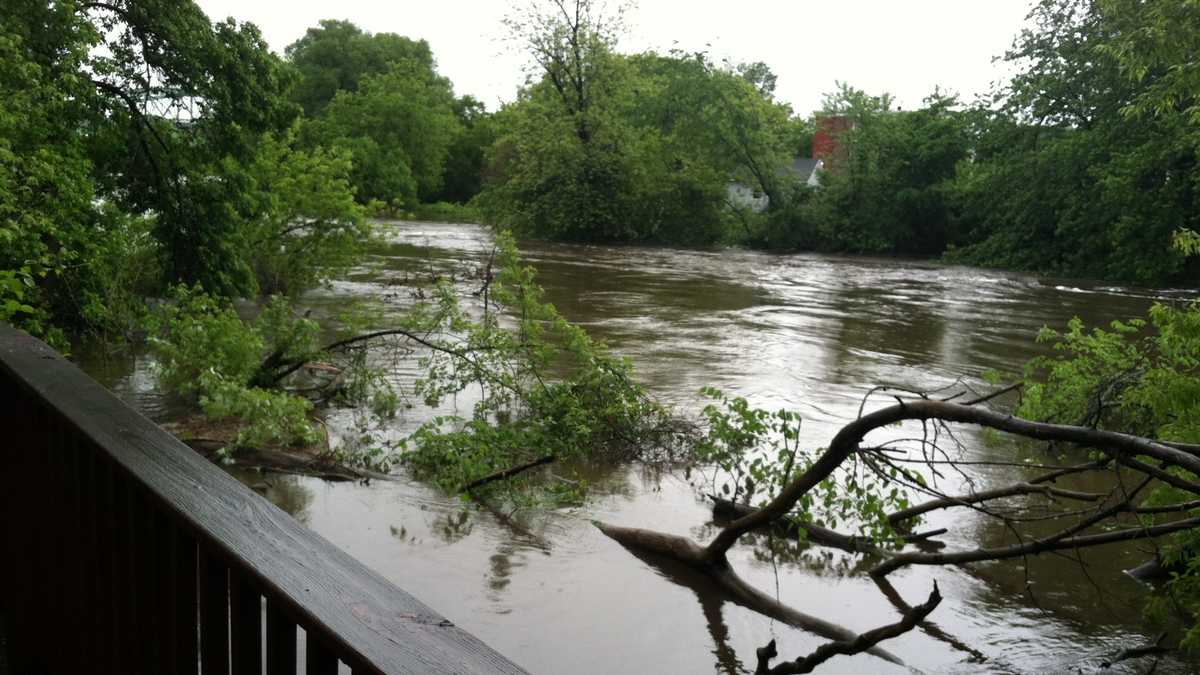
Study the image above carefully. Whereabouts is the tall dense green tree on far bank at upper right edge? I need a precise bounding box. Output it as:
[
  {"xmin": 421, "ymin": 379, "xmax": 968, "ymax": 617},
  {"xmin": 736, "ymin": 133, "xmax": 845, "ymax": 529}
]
[{"xmin": 953, "ymin": 0, "xmax": 1198, "ymax": 283}]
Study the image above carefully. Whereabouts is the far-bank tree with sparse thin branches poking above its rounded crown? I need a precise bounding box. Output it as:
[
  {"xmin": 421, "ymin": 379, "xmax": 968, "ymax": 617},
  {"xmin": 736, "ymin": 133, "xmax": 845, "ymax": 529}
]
[{"xmin": 480, "ymin": 1, "xmax": 791, "ymax": 245}]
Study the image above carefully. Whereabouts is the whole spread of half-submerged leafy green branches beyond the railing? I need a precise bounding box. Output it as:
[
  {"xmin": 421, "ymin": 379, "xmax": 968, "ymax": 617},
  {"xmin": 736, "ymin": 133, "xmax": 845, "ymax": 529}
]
[{"xmin": 138, "ymin": 229, "xmax": 685, "ymax": 482}]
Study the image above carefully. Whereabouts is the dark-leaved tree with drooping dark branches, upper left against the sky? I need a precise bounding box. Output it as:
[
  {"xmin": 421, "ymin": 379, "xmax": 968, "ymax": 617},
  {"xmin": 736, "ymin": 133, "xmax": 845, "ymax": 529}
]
[{"xmin": 79, "ymin": 1, "xmax": 299, "ymax": 294}]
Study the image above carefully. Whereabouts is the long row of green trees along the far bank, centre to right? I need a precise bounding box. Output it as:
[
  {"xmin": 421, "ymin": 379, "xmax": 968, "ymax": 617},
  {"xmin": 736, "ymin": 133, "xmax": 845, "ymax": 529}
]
[{"xmin": 476, "ymin": 0, "xmax": 1200, "ymax": 283}]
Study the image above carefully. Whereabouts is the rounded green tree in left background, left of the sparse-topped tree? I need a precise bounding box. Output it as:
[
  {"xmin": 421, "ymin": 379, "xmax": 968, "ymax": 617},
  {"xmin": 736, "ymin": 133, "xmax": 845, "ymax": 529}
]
[{"xmin": 287, "ymin": 20, "xmax": 492, "ymax": 209}]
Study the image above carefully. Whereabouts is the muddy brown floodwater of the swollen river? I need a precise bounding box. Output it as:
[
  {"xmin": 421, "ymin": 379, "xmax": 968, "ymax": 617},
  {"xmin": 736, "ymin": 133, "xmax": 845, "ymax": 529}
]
[{"xmin": 85, "ymin": 222, "xmax": 1200, "ymax": 674}]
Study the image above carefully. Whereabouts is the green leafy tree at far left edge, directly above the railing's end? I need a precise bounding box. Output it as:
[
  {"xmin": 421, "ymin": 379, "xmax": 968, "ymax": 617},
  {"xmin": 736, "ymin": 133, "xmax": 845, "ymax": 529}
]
[{"xmin": 0, "ymin": 2, "xmax": 101, "ymax": 348}]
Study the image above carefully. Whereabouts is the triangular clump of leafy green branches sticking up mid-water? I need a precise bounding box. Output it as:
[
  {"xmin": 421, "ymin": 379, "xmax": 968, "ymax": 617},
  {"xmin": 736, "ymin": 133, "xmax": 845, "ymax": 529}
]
[{"xmin": 402, "ymin": 234, "xmax": 686, "ymax": 500}]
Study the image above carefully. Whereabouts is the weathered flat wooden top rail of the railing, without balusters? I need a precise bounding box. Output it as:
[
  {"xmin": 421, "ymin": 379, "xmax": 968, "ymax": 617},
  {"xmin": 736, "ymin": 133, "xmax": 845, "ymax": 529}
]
[{"xmin": 0, "ymin": 323, "xmax": 524, "ymax": 674}]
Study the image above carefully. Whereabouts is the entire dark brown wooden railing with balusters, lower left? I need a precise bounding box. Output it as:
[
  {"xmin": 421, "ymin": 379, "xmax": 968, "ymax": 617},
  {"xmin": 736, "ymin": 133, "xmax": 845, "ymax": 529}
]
[{"xmin": 0, "ymin": 324, "xmax": 523, "ymax": 675}]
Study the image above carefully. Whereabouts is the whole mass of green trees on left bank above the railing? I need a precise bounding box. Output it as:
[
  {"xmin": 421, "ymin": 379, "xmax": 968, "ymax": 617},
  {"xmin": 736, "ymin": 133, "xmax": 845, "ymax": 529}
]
[{"xmin": 0, "ymin": 0, "xmax": 365, "ymax": 346}]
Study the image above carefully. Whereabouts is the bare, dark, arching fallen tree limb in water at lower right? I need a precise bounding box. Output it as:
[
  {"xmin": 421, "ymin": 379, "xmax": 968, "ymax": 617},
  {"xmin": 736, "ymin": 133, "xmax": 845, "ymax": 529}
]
[{"xmin": 596, "ymin": 388, "xmax": 1200, "ymax": 673}]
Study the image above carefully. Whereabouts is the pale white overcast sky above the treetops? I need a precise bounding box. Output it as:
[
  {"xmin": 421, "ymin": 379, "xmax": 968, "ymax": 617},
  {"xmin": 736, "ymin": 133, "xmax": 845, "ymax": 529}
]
[{"xmin": 198, "ymin": 0, "xmax": 1030, "ymax": 114}]
